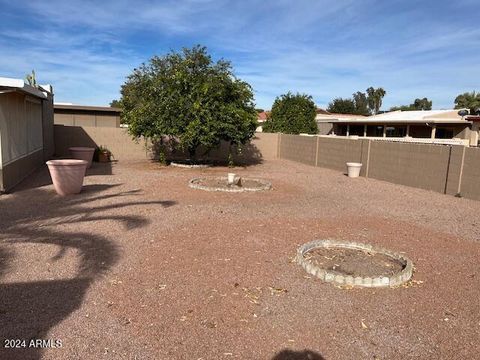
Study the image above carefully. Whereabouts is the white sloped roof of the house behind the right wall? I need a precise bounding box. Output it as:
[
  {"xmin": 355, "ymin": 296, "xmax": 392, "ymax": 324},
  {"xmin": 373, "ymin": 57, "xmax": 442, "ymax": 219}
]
[{"xmin": 320, "ymin": 110, "xmax": 469, "ymax": 124}]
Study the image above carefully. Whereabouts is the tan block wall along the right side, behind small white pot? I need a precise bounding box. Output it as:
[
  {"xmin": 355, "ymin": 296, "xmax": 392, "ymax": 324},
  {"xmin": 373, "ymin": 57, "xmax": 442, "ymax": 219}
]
[{"xmin": 278, "ymin": 134, "xmax": 480, "ymax": 200}]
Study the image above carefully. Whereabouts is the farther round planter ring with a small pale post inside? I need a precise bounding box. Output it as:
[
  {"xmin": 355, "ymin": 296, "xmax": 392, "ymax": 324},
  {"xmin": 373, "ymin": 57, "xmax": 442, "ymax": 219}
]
[{"xmin": 188, "ymin": 176, "xmax": 272, "ymax": 193}]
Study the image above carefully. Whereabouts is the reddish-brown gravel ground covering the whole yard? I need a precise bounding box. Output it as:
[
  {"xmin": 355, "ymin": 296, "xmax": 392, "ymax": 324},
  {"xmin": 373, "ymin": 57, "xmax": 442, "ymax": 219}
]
[{"xmin": 0, "ymin": 160, "xmax": 480, "ymax": 360}]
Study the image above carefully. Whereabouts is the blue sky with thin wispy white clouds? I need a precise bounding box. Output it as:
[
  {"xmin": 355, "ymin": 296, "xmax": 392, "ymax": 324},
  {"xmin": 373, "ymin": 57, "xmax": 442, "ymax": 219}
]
[{"xmin": 0, "ymin": 0, "xmax": 480, "ymax": 109}]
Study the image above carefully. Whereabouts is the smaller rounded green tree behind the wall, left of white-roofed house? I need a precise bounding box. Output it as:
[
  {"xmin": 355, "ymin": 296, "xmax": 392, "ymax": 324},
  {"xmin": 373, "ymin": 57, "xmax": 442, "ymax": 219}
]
[{"xmin": 263, "ymin": 92, "xmax": 318, "ymax": 134}]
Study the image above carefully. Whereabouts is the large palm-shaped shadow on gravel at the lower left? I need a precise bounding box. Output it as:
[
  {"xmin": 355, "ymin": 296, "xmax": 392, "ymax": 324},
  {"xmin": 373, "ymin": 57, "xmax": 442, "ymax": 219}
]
[{"xmin": 0, "ymin": 181, "xmax": 175, "ymax": 360}]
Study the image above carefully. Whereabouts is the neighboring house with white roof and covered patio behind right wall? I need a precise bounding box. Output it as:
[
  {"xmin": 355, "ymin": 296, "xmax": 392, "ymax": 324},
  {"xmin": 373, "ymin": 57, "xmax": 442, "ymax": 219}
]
[{"xmin": 317, "ymin": 110, "xmax": 478, "ymax": 146}]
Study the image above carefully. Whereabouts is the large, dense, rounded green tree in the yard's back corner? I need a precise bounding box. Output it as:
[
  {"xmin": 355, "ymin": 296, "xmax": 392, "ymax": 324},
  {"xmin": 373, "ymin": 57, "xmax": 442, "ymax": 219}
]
[{"xmin": 121, "ymin": 45, "xmax": 257, "ymax": 159}]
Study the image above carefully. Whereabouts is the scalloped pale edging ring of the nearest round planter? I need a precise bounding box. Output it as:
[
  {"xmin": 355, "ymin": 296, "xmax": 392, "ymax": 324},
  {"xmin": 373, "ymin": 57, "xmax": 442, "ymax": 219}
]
[{"xmin": 297, "ymin": 240, "xmax": 413, "ymax": 287}]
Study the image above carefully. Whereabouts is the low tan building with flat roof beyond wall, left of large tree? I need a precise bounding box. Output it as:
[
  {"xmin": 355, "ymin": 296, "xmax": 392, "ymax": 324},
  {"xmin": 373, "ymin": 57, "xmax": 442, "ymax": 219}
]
[{"xmin": 54, "ymin": 103, "xmax": 121, "ymax": 127}]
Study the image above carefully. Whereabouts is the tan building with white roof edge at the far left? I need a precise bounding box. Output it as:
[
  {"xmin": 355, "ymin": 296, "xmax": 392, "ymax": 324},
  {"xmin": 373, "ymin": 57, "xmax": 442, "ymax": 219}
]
[{"xmin": 0, "ymin": 77, "xmax": 55, "ymax": 192}]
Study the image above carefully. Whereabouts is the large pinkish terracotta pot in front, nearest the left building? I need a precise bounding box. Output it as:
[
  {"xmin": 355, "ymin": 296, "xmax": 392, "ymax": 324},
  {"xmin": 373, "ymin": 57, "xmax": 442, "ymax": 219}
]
[{"xmin": 47, "ymin": 159, "xmax": 88, "ymax": 196}]
